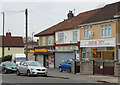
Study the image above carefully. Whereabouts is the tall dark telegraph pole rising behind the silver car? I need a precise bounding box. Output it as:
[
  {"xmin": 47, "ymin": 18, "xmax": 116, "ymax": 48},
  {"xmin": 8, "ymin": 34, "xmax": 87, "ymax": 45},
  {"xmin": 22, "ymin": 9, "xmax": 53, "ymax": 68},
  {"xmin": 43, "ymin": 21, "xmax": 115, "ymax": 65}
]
[{"xmin": 25, "ymin": 9, "xmax": 28, "ymax": 60}]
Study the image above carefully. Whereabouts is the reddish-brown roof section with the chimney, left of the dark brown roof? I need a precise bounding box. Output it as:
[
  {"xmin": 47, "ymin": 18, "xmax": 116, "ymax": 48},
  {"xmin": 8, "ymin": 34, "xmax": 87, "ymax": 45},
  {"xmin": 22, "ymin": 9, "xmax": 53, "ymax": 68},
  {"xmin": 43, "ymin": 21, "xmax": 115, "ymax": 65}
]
[{"xmin": 35, "ymin": 9, "xmax": 99, "ymax": 36}]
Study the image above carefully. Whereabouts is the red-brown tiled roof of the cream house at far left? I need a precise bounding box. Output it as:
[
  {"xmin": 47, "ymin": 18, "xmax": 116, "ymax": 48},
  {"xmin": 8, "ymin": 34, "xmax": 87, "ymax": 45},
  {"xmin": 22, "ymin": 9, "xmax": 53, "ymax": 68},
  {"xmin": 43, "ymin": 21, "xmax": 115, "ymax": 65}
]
[{"xmin": 0, "ymin": 32, "xmax": 24, "ymax": 47}]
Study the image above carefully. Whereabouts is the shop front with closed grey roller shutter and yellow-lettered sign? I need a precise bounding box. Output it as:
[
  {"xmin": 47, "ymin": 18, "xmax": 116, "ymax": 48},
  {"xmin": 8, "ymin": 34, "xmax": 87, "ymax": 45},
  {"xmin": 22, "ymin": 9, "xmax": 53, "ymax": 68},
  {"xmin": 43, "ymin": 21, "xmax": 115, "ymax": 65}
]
[{"xmin": 55, "ymin": 45, "xmax": 79, "ymax": 68}]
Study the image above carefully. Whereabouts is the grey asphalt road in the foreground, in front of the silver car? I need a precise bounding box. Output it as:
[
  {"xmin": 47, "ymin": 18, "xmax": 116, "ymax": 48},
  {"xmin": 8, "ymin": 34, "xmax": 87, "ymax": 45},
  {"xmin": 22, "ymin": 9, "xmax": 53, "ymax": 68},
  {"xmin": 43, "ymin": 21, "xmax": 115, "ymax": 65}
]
[{"xmin": 2, "ymin": 74, "xmax": 81, "ymax": 83}]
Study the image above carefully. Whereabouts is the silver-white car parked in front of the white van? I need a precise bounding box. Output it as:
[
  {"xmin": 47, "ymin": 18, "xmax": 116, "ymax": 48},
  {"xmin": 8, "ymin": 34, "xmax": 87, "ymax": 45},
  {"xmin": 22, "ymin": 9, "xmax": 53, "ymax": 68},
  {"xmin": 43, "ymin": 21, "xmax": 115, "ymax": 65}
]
[{"xmin": 16, "ymin": 61, "xmax": 47, "ymax": 76}]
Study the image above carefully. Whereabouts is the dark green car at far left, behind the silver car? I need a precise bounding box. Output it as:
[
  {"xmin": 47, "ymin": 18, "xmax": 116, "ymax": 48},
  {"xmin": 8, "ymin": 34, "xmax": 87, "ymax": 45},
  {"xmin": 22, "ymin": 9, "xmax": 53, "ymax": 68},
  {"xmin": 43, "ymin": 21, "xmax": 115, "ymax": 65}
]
[{"xmin": 0, "ymin": 61, "xmax": 17, "ymax": 73}]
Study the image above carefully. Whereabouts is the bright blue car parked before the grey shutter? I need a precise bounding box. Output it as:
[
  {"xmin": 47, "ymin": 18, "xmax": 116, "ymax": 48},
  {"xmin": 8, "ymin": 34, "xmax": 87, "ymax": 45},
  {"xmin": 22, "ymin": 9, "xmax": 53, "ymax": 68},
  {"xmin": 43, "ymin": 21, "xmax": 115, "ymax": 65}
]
[{"xmin": 59, "ymin": 59, "xmax": 72, "ymax": 72}]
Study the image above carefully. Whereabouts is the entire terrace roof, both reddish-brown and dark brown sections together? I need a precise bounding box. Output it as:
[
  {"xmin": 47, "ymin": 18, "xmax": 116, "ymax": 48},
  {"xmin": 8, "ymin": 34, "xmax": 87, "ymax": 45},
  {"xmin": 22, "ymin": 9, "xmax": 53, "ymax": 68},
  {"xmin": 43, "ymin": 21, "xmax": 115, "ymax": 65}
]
[{"xmin": 35, "ymin": 2, "xmax": 120, "ymax": 36}]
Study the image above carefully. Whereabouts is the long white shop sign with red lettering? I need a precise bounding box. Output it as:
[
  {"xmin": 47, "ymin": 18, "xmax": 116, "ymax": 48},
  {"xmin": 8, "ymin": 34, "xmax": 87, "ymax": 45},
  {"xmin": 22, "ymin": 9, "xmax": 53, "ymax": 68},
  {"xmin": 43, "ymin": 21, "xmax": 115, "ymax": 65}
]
[{"xmin": 80, "ymin": 38, "xmax": 116, "ymax": 47}]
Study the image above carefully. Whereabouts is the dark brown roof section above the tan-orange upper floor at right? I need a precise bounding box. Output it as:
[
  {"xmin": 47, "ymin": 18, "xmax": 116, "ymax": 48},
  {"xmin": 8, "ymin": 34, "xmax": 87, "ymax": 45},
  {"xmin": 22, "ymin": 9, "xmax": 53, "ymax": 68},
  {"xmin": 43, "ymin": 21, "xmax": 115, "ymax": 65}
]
[{"xmin": 82, "ymin": 2, "xmax": 120, "ymax": 24}]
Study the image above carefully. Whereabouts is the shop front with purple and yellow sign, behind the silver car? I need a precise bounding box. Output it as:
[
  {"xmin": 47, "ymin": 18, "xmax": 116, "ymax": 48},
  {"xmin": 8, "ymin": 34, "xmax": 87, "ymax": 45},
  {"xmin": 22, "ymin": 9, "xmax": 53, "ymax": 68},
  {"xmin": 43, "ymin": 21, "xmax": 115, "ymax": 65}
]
[{"xmin": 34, "ymin": 47, "xmax": 55, "ymax": 68}]
